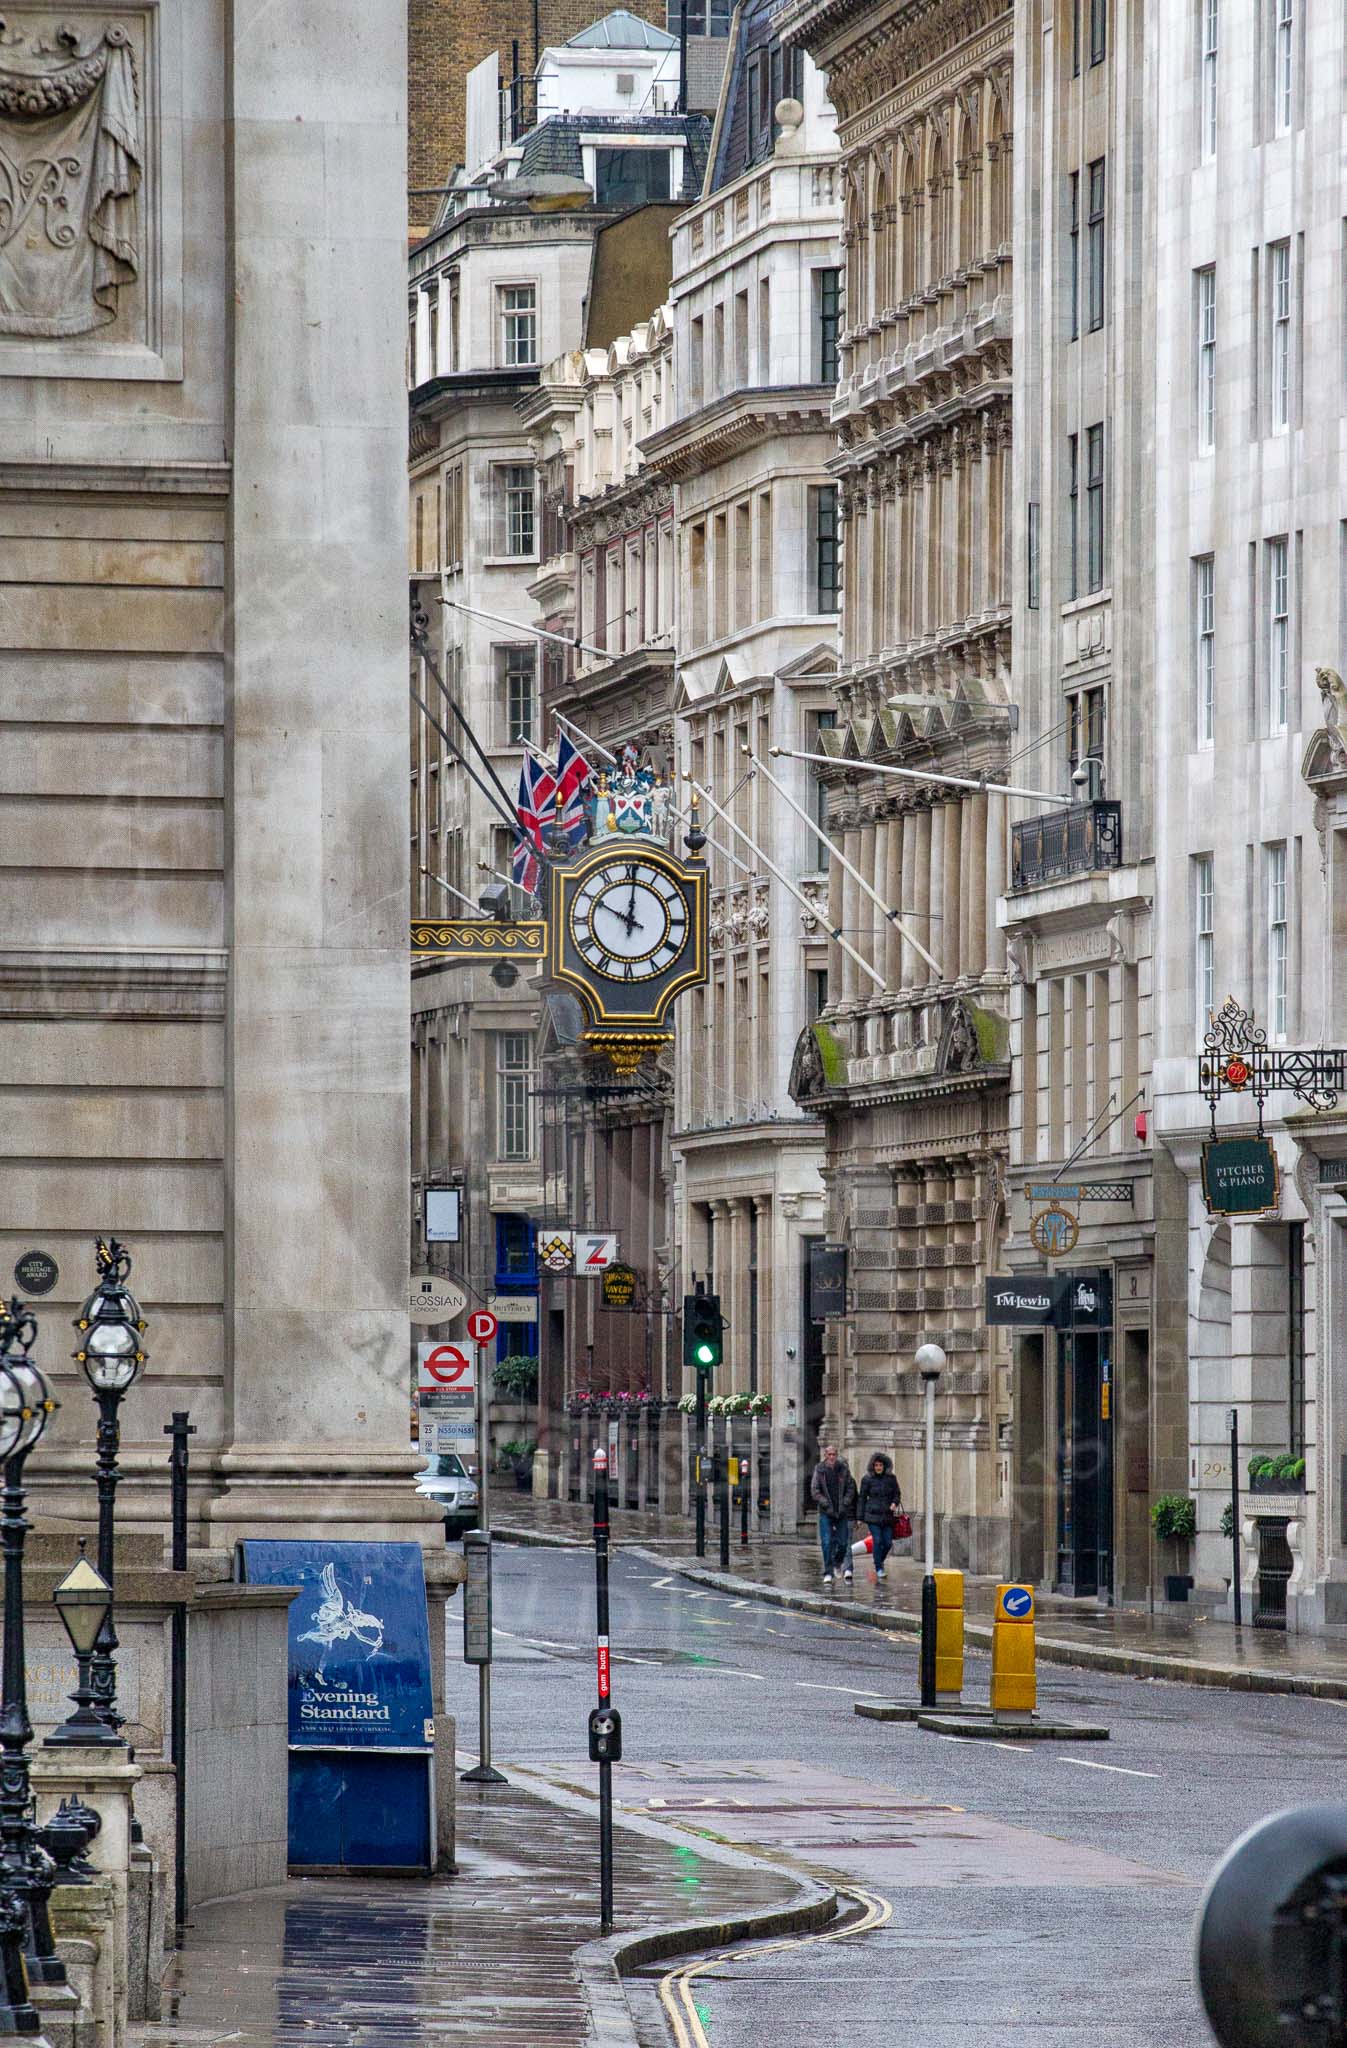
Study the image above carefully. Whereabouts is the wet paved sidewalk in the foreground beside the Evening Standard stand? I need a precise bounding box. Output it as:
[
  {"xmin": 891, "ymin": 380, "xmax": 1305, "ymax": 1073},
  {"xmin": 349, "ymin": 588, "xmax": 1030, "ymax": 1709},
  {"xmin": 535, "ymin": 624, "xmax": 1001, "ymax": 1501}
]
[{"xmin": 129, "ymin": 1765, "xmax": 818, "ymax": 2048}]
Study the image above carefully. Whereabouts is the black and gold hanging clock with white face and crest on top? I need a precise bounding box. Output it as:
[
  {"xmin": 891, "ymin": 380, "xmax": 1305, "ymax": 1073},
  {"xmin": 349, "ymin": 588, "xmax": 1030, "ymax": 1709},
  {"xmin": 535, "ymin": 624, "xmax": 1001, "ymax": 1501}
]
[{"xmin": 547, "ymin": 770, "xmax": 706, "ymax": 1075}]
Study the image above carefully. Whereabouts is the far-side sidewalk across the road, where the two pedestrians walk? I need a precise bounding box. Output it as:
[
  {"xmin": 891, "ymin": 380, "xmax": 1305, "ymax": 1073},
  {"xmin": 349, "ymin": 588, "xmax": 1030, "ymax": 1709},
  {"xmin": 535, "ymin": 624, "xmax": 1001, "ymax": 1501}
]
[{"xmin": 495, "ymin": 1495, "xmax": 1347, "ymax": 1700}]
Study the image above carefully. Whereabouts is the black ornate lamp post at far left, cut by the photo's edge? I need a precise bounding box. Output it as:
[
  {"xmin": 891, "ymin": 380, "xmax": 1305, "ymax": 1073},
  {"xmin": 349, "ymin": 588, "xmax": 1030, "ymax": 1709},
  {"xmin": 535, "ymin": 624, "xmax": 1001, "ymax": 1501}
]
[{"xmin": 0, "ymin": 1300, "xmax": 66, "ymax": 2034}]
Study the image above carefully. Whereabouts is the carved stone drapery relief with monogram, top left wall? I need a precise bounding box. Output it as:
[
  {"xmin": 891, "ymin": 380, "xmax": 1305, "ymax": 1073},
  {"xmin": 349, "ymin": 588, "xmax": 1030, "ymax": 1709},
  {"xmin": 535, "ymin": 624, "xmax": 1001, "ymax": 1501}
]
[{"xmin": 0, "ymin": 20, "xmax": 143, "ymax": 340}]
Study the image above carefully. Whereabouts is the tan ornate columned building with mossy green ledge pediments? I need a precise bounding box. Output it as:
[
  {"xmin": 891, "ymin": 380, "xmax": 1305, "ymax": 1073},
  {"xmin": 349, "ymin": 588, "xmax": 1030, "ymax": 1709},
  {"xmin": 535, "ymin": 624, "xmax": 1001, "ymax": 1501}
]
[{"xmin": 778, "ymin": 0, "xmax": 1013, "ymax": 1571}]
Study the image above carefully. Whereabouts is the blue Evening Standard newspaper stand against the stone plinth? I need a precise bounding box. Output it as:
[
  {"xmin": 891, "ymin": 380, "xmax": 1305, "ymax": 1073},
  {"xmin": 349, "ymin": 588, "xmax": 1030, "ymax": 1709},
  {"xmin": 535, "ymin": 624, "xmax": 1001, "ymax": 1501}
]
[{"xmin": 235, "ymin": 1540, "xmax": 431, "ymax": 1872}]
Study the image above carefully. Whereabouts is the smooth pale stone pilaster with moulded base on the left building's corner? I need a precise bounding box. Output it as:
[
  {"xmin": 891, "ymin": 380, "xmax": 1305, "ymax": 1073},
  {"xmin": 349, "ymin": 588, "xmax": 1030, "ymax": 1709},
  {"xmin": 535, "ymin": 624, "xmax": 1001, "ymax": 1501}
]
[{"xmin": 207, "ymin": 0, "xmax": 425, "ymax": 1544}]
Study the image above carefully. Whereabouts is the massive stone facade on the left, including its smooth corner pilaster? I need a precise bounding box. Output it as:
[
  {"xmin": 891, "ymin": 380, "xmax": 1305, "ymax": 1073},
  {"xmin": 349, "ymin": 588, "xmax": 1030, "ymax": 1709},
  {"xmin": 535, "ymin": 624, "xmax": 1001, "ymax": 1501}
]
[{"xmin": 0, "ymin": 0, "xmax": 419, "ymax": 1544}]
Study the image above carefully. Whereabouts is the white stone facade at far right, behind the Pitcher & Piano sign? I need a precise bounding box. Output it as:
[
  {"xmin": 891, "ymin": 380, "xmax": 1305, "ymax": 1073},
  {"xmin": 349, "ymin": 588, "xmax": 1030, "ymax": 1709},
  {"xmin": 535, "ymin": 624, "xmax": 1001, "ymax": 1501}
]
[{"xmin": 1153, "ymin": 8, "xmax": 1347, "ymax": 1628}]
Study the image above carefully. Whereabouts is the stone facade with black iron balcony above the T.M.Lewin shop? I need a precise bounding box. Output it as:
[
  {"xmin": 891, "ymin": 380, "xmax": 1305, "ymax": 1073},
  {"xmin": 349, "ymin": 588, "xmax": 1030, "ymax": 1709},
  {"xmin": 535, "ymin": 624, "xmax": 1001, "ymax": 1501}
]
[{"xmin": 1001, "ymin": 4, "xmax": 1187, "ymax": 1599}]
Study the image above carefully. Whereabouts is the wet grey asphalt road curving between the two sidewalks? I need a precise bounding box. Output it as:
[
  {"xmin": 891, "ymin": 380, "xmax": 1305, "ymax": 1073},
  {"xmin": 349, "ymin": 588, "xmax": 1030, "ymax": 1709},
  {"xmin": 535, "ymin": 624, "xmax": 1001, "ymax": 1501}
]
[{"xmin": 448, "ymin": 1544, "xmax": 1347, "ymax": 2048}]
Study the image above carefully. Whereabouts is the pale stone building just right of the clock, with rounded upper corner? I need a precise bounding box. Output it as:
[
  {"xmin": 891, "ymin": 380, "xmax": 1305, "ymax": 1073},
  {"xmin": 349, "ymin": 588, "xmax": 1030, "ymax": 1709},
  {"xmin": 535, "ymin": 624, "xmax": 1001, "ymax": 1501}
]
[{"xmin": 645, "ymin": 4, "xmax": 841, "ymax": 1526}]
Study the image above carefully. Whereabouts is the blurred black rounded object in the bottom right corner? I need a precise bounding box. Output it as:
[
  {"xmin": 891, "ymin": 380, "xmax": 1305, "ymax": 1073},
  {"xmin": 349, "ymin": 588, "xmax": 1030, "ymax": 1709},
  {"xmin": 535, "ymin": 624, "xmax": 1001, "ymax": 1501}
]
[{"xmin": 1196, "ymin": 1804, "xmax": 1347, "ymax": 2048}]
